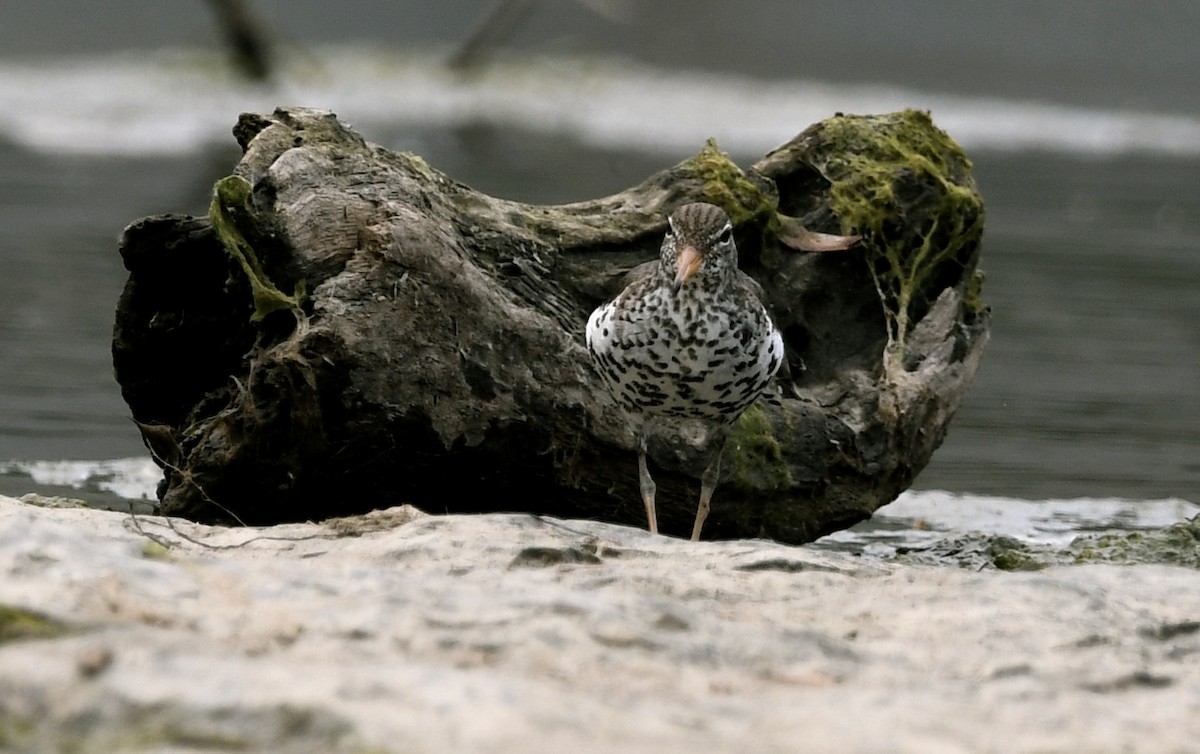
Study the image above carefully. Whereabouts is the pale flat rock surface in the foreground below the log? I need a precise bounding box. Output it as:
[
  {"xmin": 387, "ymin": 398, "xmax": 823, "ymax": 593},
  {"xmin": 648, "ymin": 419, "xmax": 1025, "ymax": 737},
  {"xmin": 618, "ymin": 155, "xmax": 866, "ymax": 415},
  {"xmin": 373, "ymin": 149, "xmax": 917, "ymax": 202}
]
[{"xmin": 0, "ymin": 497, "xmax": 1200, "ymax": 754}]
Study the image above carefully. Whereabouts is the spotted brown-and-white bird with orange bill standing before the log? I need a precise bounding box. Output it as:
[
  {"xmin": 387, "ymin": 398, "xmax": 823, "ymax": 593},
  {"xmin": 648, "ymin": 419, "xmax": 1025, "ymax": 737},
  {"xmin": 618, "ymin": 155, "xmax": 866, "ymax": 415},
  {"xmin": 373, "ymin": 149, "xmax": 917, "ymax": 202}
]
[{"xmin": 586, "ymin": 202, "xmax": 784, "ymax": 540}]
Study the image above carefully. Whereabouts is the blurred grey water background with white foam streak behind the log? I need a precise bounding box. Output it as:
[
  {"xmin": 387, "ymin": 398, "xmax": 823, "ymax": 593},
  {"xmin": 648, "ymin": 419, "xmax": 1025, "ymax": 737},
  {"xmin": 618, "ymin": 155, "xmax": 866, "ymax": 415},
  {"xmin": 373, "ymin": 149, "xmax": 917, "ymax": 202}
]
[{"xmin": 0, "ymin": 0, "xmax": 1200, "ymax": 502}]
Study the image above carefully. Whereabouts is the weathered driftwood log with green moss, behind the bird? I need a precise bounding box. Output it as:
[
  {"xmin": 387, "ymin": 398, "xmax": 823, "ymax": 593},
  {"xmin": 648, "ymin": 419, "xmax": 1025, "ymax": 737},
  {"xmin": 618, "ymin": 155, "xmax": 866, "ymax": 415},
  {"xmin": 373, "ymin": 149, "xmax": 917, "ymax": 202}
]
[{"xmin": 113, "ymin": 109, "xmax": 988, "ymax": 543}]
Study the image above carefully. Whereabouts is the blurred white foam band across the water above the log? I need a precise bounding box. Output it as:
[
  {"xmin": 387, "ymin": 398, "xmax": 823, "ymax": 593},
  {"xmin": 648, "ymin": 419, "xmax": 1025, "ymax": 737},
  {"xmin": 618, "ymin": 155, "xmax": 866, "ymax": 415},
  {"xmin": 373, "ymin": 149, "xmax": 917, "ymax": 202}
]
[{"xmin": 0, "ymin": 46, "xmax": 1200, "ymax": 157}]
